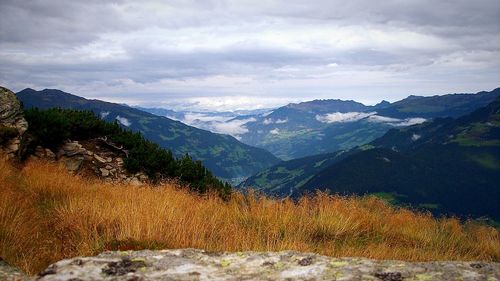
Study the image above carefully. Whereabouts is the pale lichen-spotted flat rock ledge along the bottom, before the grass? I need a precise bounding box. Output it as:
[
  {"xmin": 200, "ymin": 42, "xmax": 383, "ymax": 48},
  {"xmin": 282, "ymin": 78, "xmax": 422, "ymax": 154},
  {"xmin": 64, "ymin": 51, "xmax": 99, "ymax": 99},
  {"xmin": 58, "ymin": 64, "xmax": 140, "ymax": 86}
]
[{"xmin": 29, "ymin": 249, "xmax": 500, "ymax": 281}]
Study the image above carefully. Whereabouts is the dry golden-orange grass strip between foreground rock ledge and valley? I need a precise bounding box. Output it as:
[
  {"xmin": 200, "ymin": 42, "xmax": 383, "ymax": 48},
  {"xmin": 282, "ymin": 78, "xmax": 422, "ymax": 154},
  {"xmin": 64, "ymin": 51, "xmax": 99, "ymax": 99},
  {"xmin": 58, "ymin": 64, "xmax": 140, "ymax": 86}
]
[{"xmin": 0, "ymin": 158, "xmax": 500, "ymax": 273}]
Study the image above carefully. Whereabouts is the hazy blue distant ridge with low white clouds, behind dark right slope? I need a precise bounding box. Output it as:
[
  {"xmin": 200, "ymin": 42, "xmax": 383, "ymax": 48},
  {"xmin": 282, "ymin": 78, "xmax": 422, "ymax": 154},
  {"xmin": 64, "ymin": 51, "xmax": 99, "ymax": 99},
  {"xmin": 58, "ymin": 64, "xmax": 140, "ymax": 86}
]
[{"xmin": 233, "ymin": 89, "xmax": 500, "ymax": 160}]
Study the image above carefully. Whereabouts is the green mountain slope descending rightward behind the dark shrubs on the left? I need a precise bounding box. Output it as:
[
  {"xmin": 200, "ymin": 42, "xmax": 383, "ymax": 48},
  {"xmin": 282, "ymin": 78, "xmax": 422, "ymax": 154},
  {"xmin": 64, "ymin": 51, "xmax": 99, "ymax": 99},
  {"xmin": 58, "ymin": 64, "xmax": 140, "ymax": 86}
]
[{"xmin": 17, "ymin": 89, "xmax": 280, "ymax": 179}]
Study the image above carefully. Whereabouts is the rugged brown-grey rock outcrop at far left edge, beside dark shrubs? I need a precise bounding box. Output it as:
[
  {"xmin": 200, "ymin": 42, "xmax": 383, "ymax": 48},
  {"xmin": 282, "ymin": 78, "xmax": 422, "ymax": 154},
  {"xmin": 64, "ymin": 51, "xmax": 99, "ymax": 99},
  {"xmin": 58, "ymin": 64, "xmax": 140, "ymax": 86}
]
[{"xmin": 0, "ymin": 87, "xmax": 28, "ymax": 158}]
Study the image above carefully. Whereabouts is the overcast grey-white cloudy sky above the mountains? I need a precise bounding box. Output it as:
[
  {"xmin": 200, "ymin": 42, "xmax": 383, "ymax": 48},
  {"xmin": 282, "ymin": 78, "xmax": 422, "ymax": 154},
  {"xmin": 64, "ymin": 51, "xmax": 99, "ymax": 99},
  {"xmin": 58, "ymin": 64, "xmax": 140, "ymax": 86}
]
[{"xmin": 0, "ymin": 0, "xmax": 500, "ymax": 111}]
